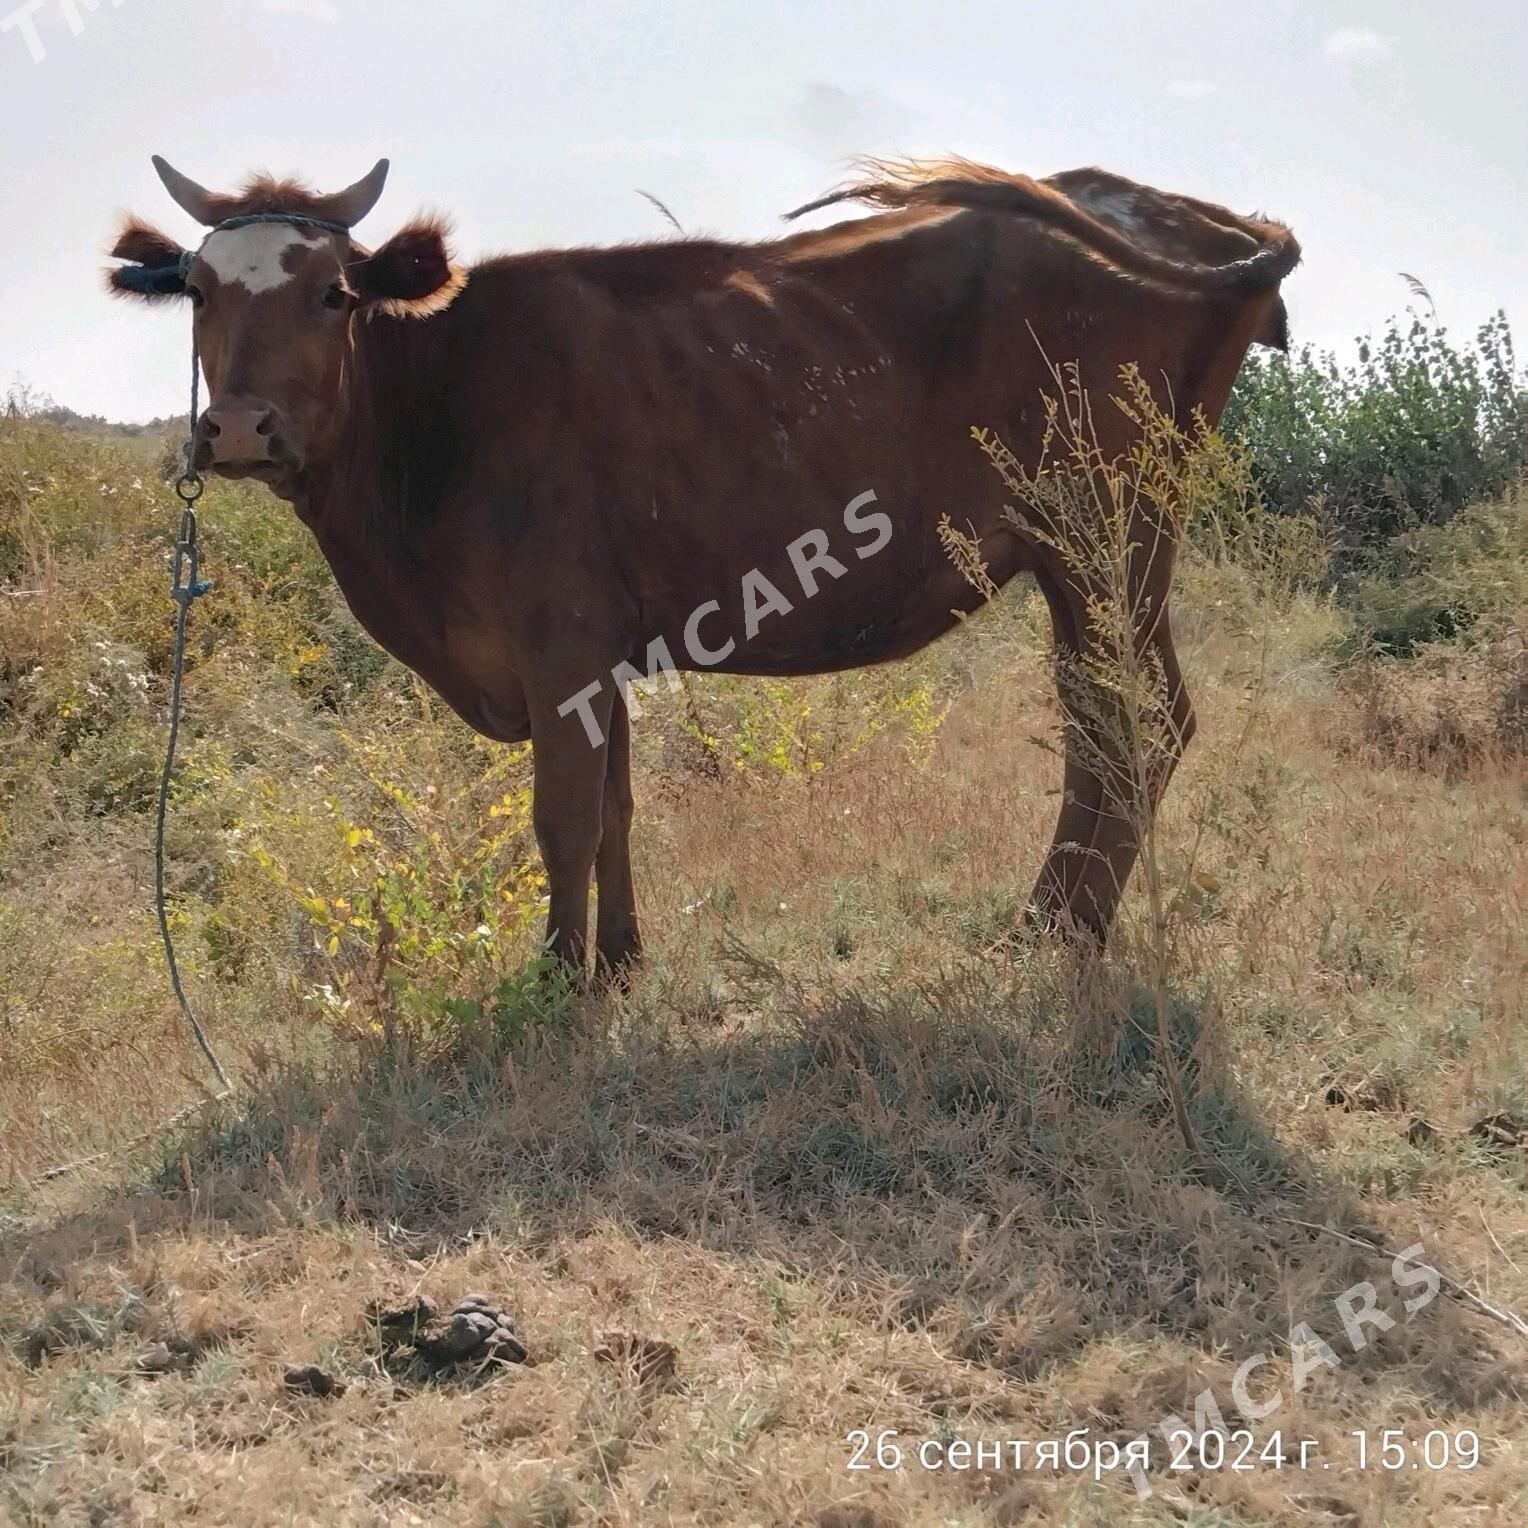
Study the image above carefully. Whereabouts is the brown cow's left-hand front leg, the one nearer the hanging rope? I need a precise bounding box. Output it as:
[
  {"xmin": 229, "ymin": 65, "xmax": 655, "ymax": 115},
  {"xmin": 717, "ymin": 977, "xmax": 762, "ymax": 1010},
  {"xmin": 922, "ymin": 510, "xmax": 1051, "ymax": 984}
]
[{"xmin": 530, "ymin": 681, "xmax": 614, "ymax": 979}]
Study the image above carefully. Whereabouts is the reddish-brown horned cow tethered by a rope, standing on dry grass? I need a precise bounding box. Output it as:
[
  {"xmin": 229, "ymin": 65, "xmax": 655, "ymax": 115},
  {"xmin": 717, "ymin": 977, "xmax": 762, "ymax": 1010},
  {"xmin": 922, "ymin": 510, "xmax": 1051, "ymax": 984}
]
[{"xmin": 110, "ymin": 159, "xmax": 1299, "ymax": 972}]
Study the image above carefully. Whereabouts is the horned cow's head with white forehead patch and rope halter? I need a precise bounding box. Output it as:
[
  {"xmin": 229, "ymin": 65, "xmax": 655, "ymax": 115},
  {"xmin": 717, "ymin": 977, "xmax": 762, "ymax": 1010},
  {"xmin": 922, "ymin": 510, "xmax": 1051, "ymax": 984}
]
[{"xmin": 107, "ymin": 157, "xmax": 466, "ymax": 497}]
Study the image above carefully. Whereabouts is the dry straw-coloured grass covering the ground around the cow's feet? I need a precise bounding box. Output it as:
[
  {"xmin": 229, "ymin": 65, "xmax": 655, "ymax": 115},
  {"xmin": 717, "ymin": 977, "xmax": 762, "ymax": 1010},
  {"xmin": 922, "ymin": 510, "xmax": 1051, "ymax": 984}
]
[{"xmin": 0, "ymin": 412, "xmax": 1528, "ymax": 1528}]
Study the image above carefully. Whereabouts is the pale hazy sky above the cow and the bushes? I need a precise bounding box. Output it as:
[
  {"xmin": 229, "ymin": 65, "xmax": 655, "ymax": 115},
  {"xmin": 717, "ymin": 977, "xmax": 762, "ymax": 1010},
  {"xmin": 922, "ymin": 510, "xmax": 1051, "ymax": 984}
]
[{"xmin": 0, "ymin": 0, "xmax": 1528, "ymax": 419}]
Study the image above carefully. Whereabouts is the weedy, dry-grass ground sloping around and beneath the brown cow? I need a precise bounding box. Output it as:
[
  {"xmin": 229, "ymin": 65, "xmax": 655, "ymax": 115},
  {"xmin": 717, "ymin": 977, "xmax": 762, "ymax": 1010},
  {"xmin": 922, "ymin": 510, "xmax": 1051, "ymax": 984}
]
[{"xmin": 0, "ymin": 328, "xmax": 1528, "ymax": 1528}]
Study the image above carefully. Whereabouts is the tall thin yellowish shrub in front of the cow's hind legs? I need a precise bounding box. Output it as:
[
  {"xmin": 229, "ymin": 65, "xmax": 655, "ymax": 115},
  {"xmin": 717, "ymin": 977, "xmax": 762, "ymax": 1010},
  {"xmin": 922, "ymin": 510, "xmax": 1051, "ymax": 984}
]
[{"xmin": 965, "ymin": 367, "xmax": 1325, "ymax": 1151}]
